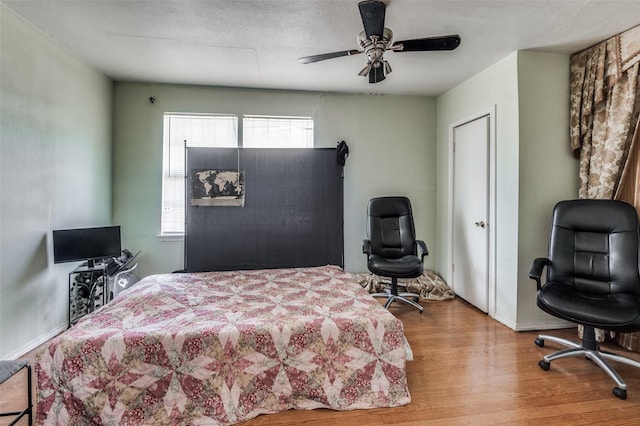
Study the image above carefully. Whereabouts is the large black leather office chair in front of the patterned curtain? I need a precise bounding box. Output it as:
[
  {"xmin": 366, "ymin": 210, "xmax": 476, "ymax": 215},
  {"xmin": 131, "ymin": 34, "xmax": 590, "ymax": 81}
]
[{"xmin": 529, "ymin": 200, "xmax": 640, "ymax": 399}]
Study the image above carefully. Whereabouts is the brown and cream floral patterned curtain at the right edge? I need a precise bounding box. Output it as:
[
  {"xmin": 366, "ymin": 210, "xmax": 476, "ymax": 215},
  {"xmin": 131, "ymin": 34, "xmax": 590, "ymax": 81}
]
[{"xmin": 570, "ymin": 26, "xmax": 640, "ymax": 202}]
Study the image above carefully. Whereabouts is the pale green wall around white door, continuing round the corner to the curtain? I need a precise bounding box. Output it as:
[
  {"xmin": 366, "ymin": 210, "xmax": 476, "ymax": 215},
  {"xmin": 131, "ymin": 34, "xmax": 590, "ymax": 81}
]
[{"xmin": 436, "ymin": 51, "xmax": 577, "ymax": 330}]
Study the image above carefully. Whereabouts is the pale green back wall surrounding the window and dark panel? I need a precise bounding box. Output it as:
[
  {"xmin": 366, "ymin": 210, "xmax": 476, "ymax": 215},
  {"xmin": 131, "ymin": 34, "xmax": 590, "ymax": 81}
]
[{"xmin": 113, "ymin": 83, "xmax": 437, "ymax": 275}]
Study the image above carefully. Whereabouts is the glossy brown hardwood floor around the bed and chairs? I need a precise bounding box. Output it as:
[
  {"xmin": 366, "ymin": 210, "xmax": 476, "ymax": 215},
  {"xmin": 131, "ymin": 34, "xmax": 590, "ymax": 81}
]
[{"xmin": 0, "ymin": 299, "xmax": 640, "ymax": 426}]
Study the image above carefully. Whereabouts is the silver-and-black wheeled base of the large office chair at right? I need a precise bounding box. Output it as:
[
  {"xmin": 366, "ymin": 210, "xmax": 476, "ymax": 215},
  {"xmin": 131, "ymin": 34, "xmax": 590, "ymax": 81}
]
[{"xmin": 535, "ymin": 327, "xmax": 640, "ymax": 399}]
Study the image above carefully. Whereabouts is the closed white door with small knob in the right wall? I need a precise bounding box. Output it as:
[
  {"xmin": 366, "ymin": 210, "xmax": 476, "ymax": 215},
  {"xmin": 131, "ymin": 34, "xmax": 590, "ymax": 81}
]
[{"xmin": 452, "ymin": 115, "xmax": 491, "ymax": 312}]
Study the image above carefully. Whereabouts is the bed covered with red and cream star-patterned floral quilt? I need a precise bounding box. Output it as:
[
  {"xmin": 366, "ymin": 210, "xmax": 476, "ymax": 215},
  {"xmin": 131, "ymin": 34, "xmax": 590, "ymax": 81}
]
[{"xmin": 35, "ymin": 266, "xmax": 412, "ymax": 425}]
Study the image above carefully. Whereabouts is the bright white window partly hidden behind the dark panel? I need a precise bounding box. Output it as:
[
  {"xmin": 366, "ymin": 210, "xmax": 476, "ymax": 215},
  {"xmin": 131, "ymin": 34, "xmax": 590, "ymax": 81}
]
[{"xmin": 160, "ymin": 113, "xmax": 313, "ymax": 236}]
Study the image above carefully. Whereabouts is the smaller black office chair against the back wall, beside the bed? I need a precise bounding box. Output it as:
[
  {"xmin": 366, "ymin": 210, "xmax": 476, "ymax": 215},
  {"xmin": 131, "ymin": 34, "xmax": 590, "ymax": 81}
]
[{"xmin": 362, "ymin": 197, "xmax": 429, "ymax": 313}]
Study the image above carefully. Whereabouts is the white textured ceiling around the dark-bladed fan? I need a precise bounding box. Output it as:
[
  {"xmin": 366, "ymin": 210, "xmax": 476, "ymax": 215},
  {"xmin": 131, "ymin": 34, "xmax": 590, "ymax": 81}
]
[{"xmin": 2, "ymin": 0, "xmax": 640, "ymax": 96}]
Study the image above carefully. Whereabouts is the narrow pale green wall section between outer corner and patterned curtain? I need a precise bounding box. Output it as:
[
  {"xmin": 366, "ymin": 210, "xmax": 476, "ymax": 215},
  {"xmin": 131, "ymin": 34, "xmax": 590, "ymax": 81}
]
[{"xmin": 516, "ymin": 51, "xmax": 578, "ymax": 329}]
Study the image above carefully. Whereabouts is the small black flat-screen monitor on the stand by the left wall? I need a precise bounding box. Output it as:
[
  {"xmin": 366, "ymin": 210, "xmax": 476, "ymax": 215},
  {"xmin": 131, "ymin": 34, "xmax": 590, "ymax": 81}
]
[{"xmin": 53, "ymin": 226, "xmax": 121, "ymax": 267}]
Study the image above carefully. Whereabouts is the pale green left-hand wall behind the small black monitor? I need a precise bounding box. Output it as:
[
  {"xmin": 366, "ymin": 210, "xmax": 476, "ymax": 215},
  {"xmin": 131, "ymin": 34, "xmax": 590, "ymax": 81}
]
[{"xmin": 0, "ymin": 4, "xmax": 113, "ymax": 359}]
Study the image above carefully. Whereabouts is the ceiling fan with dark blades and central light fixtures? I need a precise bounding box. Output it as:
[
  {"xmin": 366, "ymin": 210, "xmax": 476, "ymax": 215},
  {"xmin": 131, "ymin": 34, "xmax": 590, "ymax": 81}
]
[{"xmin": 298, "ymin": 0, "xmax": 460, "ymax": 83}]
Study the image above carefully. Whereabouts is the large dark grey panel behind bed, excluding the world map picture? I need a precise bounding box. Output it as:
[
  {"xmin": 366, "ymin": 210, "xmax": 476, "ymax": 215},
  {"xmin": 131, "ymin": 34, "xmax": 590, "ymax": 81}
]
[{"xmin": 185, "ymin": 148, "xmax": 344, "ymax": 272}]
